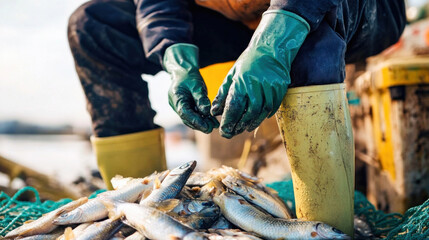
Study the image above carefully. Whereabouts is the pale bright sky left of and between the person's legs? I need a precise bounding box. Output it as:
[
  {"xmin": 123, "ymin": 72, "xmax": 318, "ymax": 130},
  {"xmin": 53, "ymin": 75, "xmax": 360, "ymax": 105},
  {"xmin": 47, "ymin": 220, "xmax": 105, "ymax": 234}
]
[{"xmin": 0, "ymin": 0, "xmax": 181, "ymax": 127}]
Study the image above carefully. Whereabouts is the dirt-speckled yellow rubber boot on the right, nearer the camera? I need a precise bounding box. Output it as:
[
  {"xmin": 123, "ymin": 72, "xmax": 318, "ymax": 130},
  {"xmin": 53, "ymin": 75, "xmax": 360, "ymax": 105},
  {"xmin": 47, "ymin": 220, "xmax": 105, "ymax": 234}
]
[{"xmin": 276, "ymin": 84, "xmax": 354, "ymax": 237}]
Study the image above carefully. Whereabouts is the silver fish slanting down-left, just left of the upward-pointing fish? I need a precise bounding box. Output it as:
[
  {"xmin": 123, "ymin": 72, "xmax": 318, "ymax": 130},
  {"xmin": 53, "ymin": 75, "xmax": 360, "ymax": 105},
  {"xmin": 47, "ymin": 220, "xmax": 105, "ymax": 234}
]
[{"xmin": 53, "ymin": 174, "xmax": 154, "ymax": 225}]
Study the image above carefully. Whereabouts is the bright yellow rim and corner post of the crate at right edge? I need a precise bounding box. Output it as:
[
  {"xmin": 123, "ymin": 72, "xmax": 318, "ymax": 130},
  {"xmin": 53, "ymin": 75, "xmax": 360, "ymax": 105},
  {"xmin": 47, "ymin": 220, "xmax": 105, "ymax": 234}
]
[{"xmin": 357, "ymin": 58, "xmax": 429, "ymax": 179}]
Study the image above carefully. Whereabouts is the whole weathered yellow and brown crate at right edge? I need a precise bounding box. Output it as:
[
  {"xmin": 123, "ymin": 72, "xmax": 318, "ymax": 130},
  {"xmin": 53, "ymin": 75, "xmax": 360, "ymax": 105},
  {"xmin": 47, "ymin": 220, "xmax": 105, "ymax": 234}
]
[{"xmin": 355, "ymin": 57, "xmax": 429, "ymax": 213}]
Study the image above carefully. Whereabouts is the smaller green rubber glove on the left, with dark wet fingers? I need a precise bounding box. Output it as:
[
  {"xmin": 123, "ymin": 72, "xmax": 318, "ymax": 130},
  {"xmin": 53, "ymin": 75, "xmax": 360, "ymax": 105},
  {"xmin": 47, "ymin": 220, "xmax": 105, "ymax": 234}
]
[{"xmin": 163, "ymin": 43, "xmax": 219, "ymax": 133}]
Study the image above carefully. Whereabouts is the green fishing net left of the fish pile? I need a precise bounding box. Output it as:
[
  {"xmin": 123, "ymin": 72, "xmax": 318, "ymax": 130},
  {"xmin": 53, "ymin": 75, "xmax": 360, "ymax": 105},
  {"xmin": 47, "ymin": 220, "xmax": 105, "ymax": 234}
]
[{"xmin": 0, "ymin": 187, "xmax": 105, "ymax": 236}]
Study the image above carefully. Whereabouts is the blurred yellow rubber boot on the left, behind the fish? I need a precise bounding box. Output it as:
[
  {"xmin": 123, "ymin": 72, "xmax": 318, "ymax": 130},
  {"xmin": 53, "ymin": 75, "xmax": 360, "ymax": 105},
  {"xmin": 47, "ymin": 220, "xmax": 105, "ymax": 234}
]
[{"xmin": 91, "ymin": 128, "xmax": 167, "ymax": 190}]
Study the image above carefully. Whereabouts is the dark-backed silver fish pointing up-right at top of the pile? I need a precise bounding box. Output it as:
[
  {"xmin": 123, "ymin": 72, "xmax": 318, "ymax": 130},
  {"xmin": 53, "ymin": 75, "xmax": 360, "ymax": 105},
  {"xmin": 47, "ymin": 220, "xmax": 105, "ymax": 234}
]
[{"xmin": 140, "ymin": 161, "xmax": 197, "ymax": 205}]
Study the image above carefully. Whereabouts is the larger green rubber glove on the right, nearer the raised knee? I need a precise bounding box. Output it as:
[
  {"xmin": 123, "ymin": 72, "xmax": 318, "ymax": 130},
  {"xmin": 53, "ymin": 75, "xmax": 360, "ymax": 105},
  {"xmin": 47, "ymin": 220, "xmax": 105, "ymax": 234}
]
[{"xmin": 211, "ymin": 10, "xmax": 310, "ymax": 138}]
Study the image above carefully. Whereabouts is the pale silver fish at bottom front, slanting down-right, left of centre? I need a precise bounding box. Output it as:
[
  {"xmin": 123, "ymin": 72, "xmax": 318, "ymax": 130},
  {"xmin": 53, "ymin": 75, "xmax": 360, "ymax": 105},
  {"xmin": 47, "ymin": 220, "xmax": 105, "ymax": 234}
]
[{"xmin": 104, "ymin": 200, "xmax": 194, "ymax": 240}]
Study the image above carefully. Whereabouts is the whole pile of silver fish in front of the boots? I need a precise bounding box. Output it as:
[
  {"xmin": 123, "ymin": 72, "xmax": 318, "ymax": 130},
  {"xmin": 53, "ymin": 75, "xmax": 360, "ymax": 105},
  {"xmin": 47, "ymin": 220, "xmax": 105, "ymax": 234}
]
[{"xmin": 5, "ymin": 161, "xmax": 350, "ymax": 240}]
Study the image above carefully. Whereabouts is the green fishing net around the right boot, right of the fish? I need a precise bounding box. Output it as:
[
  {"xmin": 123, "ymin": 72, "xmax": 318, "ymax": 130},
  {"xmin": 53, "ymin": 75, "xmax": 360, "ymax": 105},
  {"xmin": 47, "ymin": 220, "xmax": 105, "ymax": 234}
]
[{"xmin": 267, "ymin": 180, "xmax": 429, "ymax": 240}]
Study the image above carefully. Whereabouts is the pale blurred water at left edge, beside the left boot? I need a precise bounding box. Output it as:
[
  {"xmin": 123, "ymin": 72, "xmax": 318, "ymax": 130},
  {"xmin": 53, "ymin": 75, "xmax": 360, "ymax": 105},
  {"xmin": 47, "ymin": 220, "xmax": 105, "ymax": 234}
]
[{"xmin": 0, "ymin": 135, "xmax": 96, "ymax": 183}]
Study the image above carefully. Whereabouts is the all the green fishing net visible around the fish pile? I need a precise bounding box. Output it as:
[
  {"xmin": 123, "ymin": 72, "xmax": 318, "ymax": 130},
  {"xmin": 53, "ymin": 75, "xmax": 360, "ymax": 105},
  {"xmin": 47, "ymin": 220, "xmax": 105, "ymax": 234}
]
[{"xmin": 0, "ymin": 180, "xmax": 429, "ymax": 240}]
